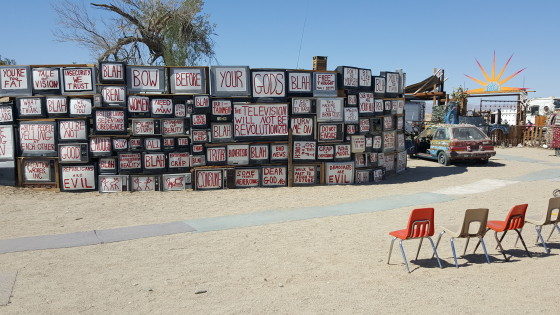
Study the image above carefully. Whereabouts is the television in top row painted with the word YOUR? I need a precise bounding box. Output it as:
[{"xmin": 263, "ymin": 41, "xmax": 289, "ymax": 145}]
[{"xmin": 211, "ymin": 66, "xmax": 251, "ymax": 97}]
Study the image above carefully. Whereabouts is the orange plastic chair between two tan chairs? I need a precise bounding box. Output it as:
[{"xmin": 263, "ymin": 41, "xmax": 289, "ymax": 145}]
[{"xmin": 474, "ymin": 203, "xmax": 532, "ymax": 261}]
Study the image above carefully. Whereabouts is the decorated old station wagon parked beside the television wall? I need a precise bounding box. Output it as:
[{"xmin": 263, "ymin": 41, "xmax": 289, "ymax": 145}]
[{"xmin": 408, "ymin": 124, "xmax": 496, "ymax": 165}]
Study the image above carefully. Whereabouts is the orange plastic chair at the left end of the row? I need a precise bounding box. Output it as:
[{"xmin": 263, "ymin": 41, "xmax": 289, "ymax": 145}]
[{"xmin": 387, "ymin": 208, "xmax": 443, "ymax": 273}]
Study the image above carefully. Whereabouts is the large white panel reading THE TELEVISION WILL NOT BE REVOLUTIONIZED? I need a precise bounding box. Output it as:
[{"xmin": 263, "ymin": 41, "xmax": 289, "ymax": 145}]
[{"xmin": 233, "ymin": 104, "xmax": 288, "ymax": 140}]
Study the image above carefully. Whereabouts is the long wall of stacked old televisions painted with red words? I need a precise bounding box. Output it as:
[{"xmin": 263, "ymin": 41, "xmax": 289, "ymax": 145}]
[{"xmin": 0, "ymin": 62, "xmax": 407, "ymax": 192}]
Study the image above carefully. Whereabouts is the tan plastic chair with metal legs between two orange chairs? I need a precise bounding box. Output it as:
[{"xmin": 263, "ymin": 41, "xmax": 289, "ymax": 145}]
[{"xmin": 436, "ymin": 208, "xmax": 490, "ymax": 268}]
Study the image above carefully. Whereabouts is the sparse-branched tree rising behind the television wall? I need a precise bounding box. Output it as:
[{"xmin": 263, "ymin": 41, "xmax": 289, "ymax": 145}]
[{"xmin": 53, "ymin": 0, "xmax": 215, "ymax": 66}]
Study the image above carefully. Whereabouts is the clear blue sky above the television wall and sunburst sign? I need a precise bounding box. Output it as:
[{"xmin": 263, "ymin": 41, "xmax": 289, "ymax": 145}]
[{"xmin": 0, "ymin": 0, "xmax": 560, "ymax": 104}]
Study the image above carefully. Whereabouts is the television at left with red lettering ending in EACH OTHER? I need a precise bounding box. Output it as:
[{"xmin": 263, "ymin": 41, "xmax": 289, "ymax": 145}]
[{"xmin": 19, "ymin": 121, "xmax": 57, "ymax": 156}]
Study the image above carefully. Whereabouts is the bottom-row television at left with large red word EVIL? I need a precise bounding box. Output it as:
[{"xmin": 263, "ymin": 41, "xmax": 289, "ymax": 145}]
[{"xmin": 60, "ymin": 164, "xmax": 97, "ymax": 191}]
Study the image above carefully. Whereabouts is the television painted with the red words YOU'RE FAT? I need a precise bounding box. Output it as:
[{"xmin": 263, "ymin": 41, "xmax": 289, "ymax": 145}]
[{"xmin": 0, "ymin": 66, "xmax": 32, "ymax": 96}]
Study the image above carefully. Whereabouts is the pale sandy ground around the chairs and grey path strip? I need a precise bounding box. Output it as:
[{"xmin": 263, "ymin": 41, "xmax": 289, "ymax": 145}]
[{"xmin": 0, "ymin": 148, "xmax": 560, "ymax": 314}]
